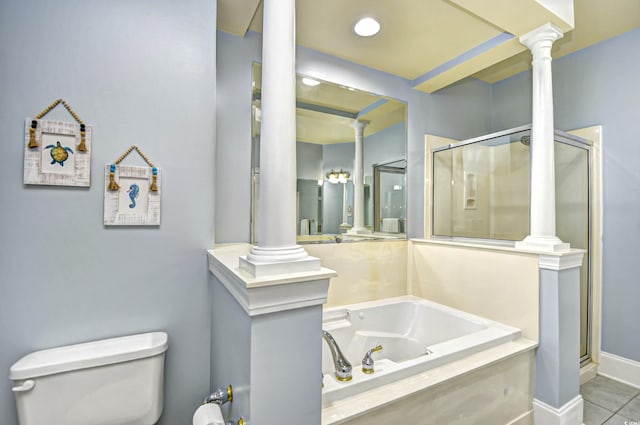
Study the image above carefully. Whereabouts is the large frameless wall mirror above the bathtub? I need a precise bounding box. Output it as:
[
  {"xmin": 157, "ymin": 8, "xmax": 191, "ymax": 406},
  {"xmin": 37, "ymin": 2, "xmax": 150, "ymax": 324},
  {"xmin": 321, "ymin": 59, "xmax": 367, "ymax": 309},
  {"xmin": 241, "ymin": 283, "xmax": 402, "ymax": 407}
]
[{"xmin": 251, "ymin": 63, "xmax": 407, "ymax": 243}]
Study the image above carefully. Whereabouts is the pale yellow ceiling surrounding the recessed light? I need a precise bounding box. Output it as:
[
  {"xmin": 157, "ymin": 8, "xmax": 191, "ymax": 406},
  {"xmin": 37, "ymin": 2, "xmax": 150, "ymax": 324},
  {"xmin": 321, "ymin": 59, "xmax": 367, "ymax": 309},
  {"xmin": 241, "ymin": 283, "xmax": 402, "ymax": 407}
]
[{"xmin": 218, "ymin": 0, "xmax": 640, "ymax": 93}]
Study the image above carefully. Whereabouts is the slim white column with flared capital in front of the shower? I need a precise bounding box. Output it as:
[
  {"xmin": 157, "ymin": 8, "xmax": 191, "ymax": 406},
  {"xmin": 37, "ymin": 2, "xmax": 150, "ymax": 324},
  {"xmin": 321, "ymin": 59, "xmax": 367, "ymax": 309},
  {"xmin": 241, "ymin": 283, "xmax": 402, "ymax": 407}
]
[{"xmin": 516, "ymin": 24, "xmax": 569, "ymax": 252}]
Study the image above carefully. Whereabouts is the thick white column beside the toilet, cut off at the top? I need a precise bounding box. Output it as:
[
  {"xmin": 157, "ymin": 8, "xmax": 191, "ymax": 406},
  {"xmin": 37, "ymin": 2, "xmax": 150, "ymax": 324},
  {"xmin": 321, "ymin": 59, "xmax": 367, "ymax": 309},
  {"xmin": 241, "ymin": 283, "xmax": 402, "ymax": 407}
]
[{"xmin": 240, "ymin": 0, "xmax": 320, "ymax": 277}]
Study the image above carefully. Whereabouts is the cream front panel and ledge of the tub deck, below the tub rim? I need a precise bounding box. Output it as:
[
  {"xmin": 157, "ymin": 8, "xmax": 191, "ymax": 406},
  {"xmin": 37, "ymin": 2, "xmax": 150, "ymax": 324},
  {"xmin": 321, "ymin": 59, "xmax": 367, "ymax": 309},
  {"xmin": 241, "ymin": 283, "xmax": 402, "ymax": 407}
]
[{"xmin": 322, "ymin": 339, "xmax": 536, "ymax": 425}]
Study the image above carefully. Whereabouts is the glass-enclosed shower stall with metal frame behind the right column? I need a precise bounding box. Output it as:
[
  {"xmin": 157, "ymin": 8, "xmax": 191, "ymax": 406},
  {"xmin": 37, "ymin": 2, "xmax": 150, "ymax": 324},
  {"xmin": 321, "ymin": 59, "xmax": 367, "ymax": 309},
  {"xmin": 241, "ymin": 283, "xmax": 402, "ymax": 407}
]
[{"xmin": 431, "ymin": 126, "xmax": 592, "ymax": 363}]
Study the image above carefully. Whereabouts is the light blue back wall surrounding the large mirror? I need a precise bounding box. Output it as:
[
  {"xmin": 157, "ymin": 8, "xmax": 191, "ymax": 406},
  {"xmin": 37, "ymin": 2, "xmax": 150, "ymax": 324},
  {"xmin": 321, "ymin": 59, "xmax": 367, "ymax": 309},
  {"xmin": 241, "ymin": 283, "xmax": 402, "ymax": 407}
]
[{"xmin": 216, "ymin": 32, "xmax": 491, "ymax": 243}]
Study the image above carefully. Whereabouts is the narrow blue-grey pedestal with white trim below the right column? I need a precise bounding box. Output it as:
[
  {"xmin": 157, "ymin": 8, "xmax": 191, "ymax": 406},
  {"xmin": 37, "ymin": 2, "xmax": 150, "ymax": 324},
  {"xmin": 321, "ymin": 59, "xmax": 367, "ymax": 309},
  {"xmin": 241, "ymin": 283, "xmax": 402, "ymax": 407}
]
[{"xmin": 534, "ymin": 250, "xmax": 584, "ymax": 425}]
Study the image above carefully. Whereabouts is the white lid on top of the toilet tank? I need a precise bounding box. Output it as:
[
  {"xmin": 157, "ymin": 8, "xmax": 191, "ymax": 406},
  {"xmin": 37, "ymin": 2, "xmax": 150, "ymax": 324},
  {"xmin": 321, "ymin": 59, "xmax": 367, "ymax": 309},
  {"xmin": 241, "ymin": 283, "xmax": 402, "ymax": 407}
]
[{"xmin": 9, "ymin": 332, "xmax": 169, "ymax": 380}]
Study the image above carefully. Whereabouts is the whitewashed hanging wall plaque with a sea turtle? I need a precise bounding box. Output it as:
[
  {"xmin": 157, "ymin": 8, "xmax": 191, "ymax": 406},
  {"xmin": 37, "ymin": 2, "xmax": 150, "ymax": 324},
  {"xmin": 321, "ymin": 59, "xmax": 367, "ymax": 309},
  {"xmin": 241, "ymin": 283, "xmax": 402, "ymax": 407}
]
[{"xmin": 23, "ymin": 99, "xmax": 92, "ymax": 187}]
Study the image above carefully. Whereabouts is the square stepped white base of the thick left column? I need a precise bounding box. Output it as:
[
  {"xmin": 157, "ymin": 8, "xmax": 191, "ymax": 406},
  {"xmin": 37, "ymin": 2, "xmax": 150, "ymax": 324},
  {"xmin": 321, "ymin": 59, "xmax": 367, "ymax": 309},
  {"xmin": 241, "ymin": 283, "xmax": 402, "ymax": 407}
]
[{"xmin": 239, "ymin": 245, "xmax": 321, "ymax": 277}]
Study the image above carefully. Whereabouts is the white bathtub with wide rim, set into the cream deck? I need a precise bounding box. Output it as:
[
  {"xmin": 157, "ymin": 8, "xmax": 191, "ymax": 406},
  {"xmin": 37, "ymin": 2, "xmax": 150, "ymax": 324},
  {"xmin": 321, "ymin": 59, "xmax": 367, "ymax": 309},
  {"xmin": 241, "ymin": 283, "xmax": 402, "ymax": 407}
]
[{"xmin": 322, "ymin": 296, "xmax": 520, "ymax": 407}]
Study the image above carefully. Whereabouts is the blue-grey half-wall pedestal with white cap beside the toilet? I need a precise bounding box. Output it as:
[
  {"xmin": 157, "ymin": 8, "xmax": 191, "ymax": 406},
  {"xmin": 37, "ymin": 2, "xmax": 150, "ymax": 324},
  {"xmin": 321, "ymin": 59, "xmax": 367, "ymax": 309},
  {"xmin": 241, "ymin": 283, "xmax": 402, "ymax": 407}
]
[{"xmin": 208, "ymin": 244, "xmax": 335, "ymax": 424}]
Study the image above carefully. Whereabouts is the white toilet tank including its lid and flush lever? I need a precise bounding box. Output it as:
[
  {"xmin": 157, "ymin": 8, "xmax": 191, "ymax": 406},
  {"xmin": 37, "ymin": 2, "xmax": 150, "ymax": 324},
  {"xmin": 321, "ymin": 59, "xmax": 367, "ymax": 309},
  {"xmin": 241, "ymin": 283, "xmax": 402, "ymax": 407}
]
[{"xmin": 9, "ymin": 332, "xmax": 168, "ymax": 425}]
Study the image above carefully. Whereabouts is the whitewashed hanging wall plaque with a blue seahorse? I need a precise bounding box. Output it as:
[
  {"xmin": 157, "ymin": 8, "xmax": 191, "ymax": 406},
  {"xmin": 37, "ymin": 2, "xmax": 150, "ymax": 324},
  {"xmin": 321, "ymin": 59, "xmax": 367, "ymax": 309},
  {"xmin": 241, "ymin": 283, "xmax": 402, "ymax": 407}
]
[{"xmin": 104, "ymin": 146, "xmax": 161, "ymax": 226}]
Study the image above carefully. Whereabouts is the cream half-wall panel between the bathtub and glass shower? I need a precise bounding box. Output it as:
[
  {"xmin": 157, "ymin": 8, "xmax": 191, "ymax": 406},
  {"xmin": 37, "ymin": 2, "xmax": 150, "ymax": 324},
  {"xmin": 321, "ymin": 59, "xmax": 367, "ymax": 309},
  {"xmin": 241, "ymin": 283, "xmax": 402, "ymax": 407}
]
[{"xmin": 408, "ymin": 239, "xmax": 539, "ymax": 341}]
